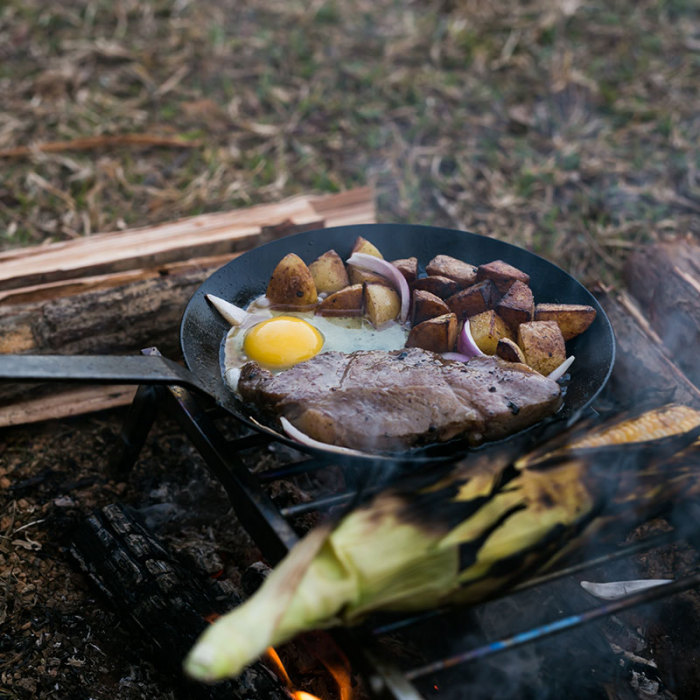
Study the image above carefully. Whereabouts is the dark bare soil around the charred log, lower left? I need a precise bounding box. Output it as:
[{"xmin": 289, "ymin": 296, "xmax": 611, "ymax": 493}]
[{"xmin": 0, "ymin": 410, "xmax": 260, "ymax": 699}]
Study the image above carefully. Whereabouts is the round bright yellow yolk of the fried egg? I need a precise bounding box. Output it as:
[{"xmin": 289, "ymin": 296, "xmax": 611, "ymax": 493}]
[{"xmin": 243, "ymin": 316, "xmax": 323, "ymax": 369}]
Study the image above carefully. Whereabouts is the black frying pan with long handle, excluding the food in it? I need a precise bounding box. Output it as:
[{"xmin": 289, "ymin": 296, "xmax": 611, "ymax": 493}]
[{"xmin": 0, "ymin": 224, "xmax": 615, "ymax": 461}]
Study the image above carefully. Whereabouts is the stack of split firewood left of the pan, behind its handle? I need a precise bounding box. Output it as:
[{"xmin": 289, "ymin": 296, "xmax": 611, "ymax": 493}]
[{"xmin": 0, "ymin": 188, "xmax": 375, "ymax": 427}]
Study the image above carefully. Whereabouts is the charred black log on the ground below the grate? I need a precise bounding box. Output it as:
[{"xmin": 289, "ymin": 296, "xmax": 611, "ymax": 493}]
[{"xmin": 70, "ymin": 504, "xmax": 289, "ymax": 700}]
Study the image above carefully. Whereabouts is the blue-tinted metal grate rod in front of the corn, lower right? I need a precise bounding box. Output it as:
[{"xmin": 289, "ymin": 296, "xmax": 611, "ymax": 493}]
[{"xmin": 405, "ymin": 572, "xmax": 700, "ymax": 680}]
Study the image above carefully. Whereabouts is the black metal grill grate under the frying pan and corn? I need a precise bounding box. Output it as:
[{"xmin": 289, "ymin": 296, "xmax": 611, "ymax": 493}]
[{"xmin": 112, "ymin": 374, "xmax": 700, "ymax": 700}]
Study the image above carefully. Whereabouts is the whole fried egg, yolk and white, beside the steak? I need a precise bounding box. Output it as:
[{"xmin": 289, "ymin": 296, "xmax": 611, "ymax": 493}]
[{"xmin": 224, "ymin": 296, "xmax": 408, "ymax": 390}]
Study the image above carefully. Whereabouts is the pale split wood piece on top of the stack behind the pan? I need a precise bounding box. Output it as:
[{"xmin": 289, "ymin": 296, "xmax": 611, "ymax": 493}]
[{"xmin": 0, "ymin": 187, "xmax": 374, "ymax": 289}]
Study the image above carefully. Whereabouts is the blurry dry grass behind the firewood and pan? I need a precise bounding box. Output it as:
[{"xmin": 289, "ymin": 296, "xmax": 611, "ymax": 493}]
[{"xmin": 0, "ymin": 0, "xmax": 700, "ymax": 281}]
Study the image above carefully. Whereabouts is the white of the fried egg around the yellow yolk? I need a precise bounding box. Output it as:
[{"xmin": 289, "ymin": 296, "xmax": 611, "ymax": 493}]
[{"xmin": 224, "ymin": 301, "xmax": 408, "ymax": 391}]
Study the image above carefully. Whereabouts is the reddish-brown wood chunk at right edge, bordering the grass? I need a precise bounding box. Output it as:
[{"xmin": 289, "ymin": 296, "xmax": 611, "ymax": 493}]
[{"xmin": 624, "ymin": 238, "xmax": 700, "ymax": 387}]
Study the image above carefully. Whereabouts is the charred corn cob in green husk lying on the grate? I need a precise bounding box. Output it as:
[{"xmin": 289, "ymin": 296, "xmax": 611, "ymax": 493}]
[{"xmin": 185, "ymin": 406, "xmax": 700, "ymax": 681}]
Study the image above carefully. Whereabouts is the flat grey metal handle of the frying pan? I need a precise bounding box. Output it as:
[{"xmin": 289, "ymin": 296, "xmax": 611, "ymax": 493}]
[{"xmin": 0, "ymin": 354, "xmax": 211, "ymax": 396}]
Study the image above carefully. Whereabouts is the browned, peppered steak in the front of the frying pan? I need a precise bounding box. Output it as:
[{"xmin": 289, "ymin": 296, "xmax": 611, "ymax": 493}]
[{"xmin": 238, "ymin": 348, "xmax": 561, "ymax": 450}]
